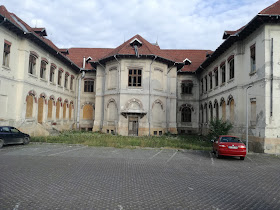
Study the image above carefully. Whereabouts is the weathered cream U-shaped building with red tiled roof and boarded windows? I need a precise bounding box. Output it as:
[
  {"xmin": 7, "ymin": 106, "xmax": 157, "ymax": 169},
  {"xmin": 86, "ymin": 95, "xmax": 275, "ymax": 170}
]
[{"xmin": 0, "ymin": 1, "xmax": 280, "ymax": 153}]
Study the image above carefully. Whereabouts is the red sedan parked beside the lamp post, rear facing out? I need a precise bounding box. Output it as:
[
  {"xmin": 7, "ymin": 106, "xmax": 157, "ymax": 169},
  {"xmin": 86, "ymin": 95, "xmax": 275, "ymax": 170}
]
[{"xmin": 212, "ymin": 135, "xmax": 246, "ymax": 160}]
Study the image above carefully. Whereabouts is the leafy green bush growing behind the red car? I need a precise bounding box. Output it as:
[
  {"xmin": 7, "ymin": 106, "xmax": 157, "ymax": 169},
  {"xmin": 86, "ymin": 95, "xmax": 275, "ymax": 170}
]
[{"xmin": 208, "ymin": 119, "xmax": 232, "ymax": 139}]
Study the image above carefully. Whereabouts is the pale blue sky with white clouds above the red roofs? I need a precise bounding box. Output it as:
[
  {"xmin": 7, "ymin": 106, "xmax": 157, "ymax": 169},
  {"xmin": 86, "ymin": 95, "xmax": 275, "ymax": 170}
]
[{"xmin": 0, "ymin": 0, "xmax": 276, "ymax": 50}]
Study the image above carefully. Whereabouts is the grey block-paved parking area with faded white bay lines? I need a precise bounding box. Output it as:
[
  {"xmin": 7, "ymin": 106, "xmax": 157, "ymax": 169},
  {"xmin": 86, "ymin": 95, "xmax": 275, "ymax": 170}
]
[{"xmin": 0, "ymin": 144, "xmax": 280, "ymax": 210}]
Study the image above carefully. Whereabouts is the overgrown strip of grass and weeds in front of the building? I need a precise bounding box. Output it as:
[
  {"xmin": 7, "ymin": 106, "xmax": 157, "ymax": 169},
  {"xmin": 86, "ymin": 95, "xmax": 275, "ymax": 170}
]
[{"xmin": 31, "ymin": 131, "xmax": 212, "ymax": 150}]
